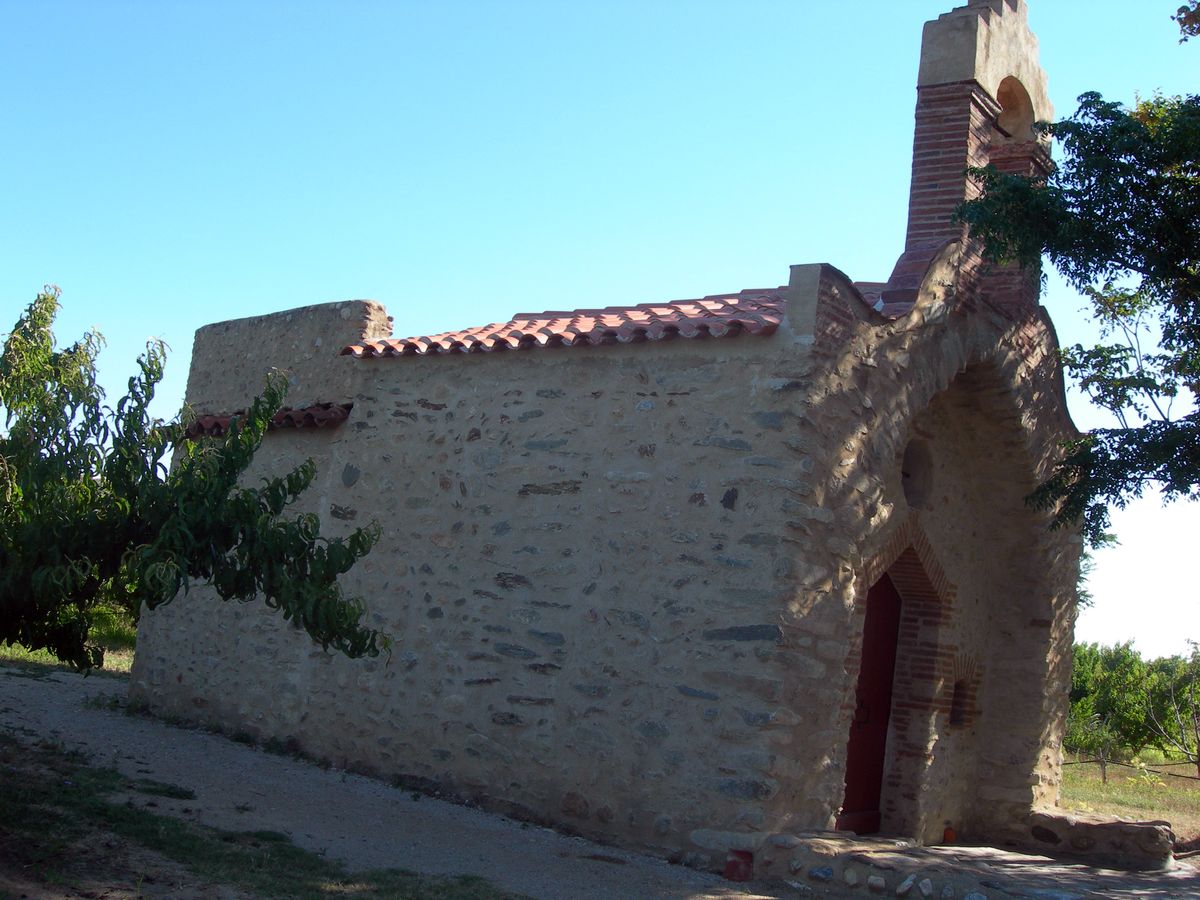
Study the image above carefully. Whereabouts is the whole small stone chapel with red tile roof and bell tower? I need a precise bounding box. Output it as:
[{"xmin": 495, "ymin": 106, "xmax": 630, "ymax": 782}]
[{"xmin": 132, "ymin": 0, "xmax": 1161, "ymax": 883}]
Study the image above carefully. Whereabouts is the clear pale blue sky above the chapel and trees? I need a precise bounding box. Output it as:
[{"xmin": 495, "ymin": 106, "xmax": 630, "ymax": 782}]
[{"xmin": 0, "ymin": 0, "xmax": 1200, "ymax": 655}]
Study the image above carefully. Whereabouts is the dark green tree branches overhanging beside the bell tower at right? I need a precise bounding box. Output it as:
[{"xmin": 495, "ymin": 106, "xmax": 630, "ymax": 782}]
[{"xmin": 959, "ymin": 74, "xmax": 1200, "ymax": 545}]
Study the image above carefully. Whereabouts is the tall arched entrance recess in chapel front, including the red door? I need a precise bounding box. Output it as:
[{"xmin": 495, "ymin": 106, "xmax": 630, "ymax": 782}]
[{"xmin": 830, "ymin": 355, "xmax": 1075, "ymax": 842}]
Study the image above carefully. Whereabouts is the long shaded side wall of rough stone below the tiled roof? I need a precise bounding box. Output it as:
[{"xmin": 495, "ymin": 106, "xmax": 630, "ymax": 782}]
[{"xmin": 134, "ymin": 271, "xmax": 859, "ymax": 864}]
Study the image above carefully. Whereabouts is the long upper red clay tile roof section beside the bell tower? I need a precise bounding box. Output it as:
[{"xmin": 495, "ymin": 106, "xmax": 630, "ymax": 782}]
[{"xmin": 342, "ymin": 288, "xmax": 786, "ymax": 359}]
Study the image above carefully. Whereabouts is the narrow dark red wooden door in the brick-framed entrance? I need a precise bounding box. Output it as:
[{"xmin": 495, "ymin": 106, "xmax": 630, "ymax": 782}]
[{"xmin": 838, "ymin": 575, "xmax": 900, "ymax": 834}]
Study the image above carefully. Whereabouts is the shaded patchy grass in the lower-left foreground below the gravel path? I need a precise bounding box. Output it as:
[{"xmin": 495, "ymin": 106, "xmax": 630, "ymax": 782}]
[{"xmin": 0, "ymin": 736, "xmax": 512, "ymax": 900}]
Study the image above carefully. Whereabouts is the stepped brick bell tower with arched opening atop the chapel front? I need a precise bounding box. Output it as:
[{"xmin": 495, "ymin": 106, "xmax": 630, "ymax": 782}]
[{"xmin": 881, "ymin": 0, "xmax": 1054, "ymax": 318}]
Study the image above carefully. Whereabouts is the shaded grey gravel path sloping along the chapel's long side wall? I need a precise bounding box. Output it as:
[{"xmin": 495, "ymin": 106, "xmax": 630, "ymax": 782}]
[{"xmin": 0, "ymin": 666, "xmax": 794, "ymax": 900}]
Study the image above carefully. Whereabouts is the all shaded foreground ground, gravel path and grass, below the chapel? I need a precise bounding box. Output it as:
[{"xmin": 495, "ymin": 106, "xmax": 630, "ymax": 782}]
[{"xmin": 7, "ymin": 664, "xmax": 1200, "ymax": 900}]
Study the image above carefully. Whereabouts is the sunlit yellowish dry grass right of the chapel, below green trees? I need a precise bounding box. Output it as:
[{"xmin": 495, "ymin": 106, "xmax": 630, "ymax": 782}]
[{"xmin": 1061, "ymin": 763, "xmax": 1200, "ymax": 841}]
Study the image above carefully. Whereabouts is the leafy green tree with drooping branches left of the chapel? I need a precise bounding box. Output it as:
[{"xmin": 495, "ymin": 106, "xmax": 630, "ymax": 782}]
[{"xmin": 0, "ymin": 288, "xmax": 386, "ymax": 668}]
